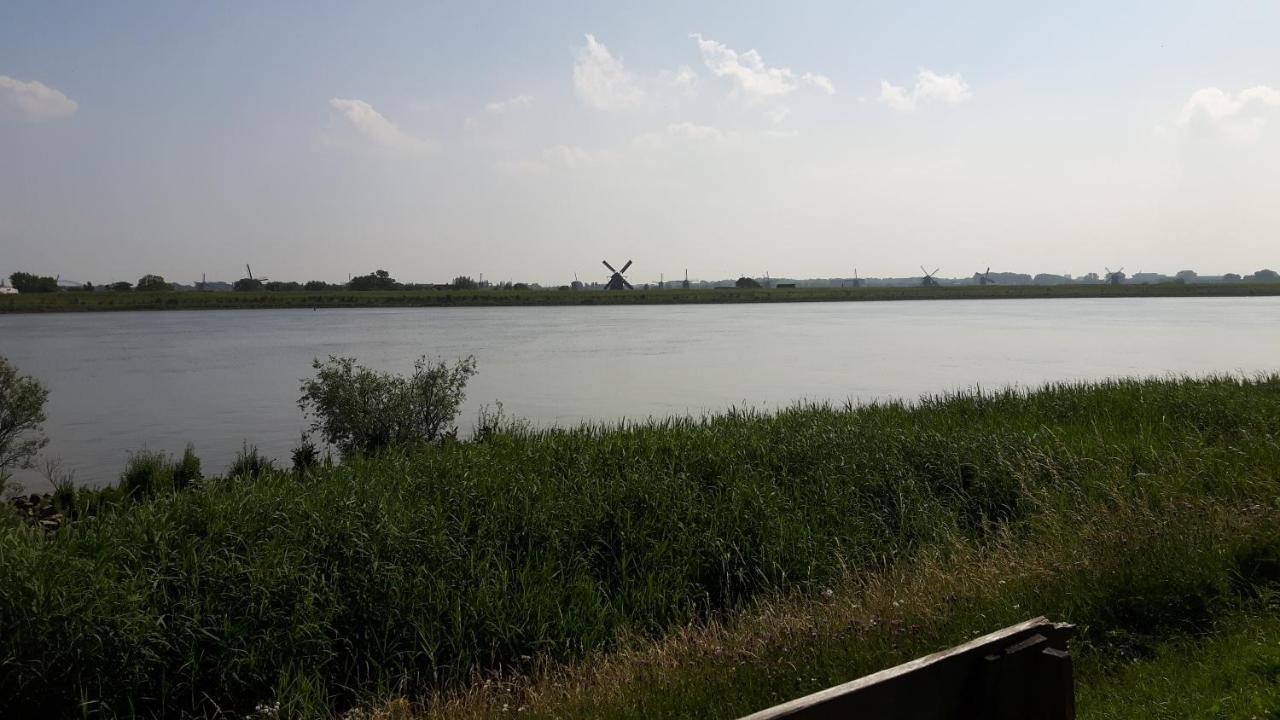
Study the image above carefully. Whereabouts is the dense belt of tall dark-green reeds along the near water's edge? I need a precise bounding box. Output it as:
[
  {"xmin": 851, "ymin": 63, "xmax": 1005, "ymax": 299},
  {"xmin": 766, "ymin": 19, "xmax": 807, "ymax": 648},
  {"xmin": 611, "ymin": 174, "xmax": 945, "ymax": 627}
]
[{"xmin": 0, "ymin": 375, "xmax": 1280, "ymax": 715}]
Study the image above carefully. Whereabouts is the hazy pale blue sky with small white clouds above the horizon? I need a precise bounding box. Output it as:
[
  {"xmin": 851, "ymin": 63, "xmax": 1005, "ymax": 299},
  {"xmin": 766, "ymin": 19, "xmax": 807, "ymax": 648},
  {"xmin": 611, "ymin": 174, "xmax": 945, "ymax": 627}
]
[{"xmin": 0, "ymin": 0, "xmax": 1280, "ymax": 284}]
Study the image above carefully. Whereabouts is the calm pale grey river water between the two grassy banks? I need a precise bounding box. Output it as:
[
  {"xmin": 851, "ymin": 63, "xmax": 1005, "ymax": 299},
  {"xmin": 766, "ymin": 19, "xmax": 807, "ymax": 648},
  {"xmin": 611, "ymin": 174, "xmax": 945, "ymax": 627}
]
[{"xmin": 0, "ymin": 297, "xmax": 1280, "ymax": 489}]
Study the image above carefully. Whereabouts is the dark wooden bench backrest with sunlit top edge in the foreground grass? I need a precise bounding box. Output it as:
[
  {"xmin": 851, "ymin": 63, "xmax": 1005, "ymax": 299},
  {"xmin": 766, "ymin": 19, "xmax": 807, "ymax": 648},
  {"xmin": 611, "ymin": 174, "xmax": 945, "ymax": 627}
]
[{"xmin": 742, "ymin": 609, "xmax": 1074, "ymax": 720}]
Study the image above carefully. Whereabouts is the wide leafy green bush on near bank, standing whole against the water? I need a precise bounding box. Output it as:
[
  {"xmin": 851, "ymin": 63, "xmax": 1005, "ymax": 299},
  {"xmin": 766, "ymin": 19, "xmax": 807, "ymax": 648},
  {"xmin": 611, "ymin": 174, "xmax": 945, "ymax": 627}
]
[{"xmin": 298, "ymin": 355, "xmax": 476, "ymax": 456}]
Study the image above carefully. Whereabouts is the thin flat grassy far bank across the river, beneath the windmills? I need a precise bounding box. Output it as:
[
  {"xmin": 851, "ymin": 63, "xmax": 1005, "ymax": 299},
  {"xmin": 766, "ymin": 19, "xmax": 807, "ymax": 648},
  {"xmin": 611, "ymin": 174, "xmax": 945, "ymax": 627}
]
[{"xmin": 0, "ymin": 283, "xmax": 1280, "ymax": 313}]
